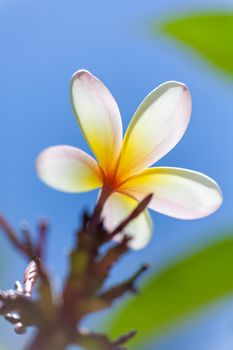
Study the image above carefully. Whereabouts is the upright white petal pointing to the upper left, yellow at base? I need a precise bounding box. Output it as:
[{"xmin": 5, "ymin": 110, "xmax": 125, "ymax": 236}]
[{"xmin": 71, "ymin": 70, "xmax": 122, "ymax": 173}]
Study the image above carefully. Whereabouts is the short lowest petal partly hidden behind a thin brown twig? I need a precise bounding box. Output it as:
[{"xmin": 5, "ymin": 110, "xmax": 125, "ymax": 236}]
[{"xmin": 103, "ymin": 193, "xmax": 152, "ymax": 249}]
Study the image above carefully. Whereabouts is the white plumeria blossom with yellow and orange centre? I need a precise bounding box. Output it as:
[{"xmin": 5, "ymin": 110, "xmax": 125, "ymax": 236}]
[{"xmin": 37, "ymin": 70, "xmax": 222, "ymax": 249}]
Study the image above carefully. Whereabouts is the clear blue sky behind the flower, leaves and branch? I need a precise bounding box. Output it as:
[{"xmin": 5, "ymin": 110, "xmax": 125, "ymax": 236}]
[{"xmin": 0, "ymin": 0, "xmax": 233, "ymax": 350}]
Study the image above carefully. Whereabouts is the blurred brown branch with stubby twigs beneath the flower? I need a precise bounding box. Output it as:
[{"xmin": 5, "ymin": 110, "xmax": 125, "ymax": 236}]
[{"xmin": 0, "ymin": 193, "xmax": 152, "ymax": 350}]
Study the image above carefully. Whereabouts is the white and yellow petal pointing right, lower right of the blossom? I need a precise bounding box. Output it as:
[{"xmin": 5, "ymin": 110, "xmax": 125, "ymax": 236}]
[{"xmin": 120, "ymin": 167, "xmax": 223, "ymax": 219}]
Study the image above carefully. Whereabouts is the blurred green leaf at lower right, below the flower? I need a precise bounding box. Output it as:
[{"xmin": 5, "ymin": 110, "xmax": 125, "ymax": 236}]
[{"xmin": 108, "ymin": 231, "xmax": 233, "ymax": 349}]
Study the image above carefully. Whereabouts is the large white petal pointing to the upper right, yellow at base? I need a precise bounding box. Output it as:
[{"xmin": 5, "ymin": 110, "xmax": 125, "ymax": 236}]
[{"xmin": 118, "ymin": 81, "xmax": 192, "ymax": 179}]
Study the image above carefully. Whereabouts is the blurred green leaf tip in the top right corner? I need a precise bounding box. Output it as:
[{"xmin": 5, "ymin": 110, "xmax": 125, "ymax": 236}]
[{"xmin": 158, "ymin": 12, "xmax": 233, "ymax": 74}]
